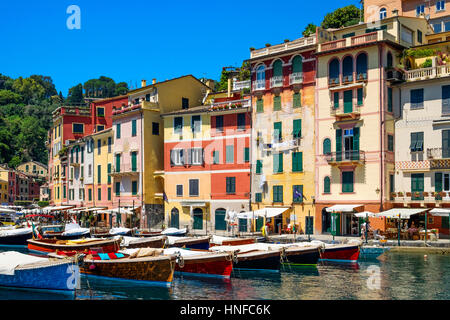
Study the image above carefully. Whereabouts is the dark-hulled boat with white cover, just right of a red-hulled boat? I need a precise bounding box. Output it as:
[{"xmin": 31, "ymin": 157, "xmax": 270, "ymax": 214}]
[{"xmin": 210, "ymin": 243, "xmax": 281, "ymax": 272}]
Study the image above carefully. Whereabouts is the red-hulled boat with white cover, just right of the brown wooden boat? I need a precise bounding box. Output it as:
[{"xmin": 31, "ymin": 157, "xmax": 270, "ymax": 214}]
[{"xmin": 164, "ymin": 248, "xmax": 233, "ymax": 278}]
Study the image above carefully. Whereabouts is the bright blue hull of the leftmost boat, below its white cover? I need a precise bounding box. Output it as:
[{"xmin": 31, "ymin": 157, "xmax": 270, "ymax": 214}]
[{"xmin": 0, "ymin": 263, "xmax": 76, "ymax": 292}]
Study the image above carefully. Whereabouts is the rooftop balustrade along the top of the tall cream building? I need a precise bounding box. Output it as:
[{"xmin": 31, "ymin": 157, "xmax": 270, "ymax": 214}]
[{"xmin": 317, "ymin": 30, "xmax": 397, "ymax": 52}]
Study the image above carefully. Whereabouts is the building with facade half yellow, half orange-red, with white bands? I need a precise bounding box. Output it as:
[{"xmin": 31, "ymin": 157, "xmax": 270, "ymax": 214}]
[{"xmin": 162, "ymin": 92, "xmax": 251, "ymax": 234}]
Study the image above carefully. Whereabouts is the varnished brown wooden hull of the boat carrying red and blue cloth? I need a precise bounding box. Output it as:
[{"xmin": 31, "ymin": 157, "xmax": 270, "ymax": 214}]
[{"xmin": 80, "ymin": 256, "xmax": 175, "ymax": 286}]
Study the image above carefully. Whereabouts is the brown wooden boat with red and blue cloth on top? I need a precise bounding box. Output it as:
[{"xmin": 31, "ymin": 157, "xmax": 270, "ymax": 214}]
[{"xmin": 80, "ymin": 248, "xmax": 176, "ymax": 286}]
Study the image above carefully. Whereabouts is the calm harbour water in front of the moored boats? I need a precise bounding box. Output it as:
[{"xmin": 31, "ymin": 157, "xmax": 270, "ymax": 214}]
[{"xmin": 0, "ymin": 249, "xmax": 450, "ymax": 300}]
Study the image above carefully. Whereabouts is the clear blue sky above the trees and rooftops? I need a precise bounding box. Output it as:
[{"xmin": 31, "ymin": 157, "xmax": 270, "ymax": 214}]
[{"xmin": 0, "ymin": 0, "xmax": 359, "ymax": 96}]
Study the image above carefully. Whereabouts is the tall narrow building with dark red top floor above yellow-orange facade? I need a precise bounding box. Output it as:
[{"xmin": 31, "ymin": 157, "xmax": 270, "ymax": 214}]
[{"xmin": 248, "ymin": 35, "xmax": 317, "ymax": 233}]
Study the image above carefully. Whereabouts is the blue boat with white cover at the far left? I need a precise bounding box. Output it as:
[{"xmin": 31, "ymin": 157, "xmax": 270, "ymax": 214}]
[{"xmin": 0, "ymin": 251, "xmax": 79, "ymax": 293}]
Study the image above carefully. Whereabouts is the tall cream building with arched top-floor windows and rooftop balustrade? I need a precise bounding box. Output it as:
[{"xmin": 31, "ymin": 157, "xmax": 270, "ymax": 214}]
[{"xmin": 315, "ymin": 16, "xmax": 432, "ymax": 235}]
